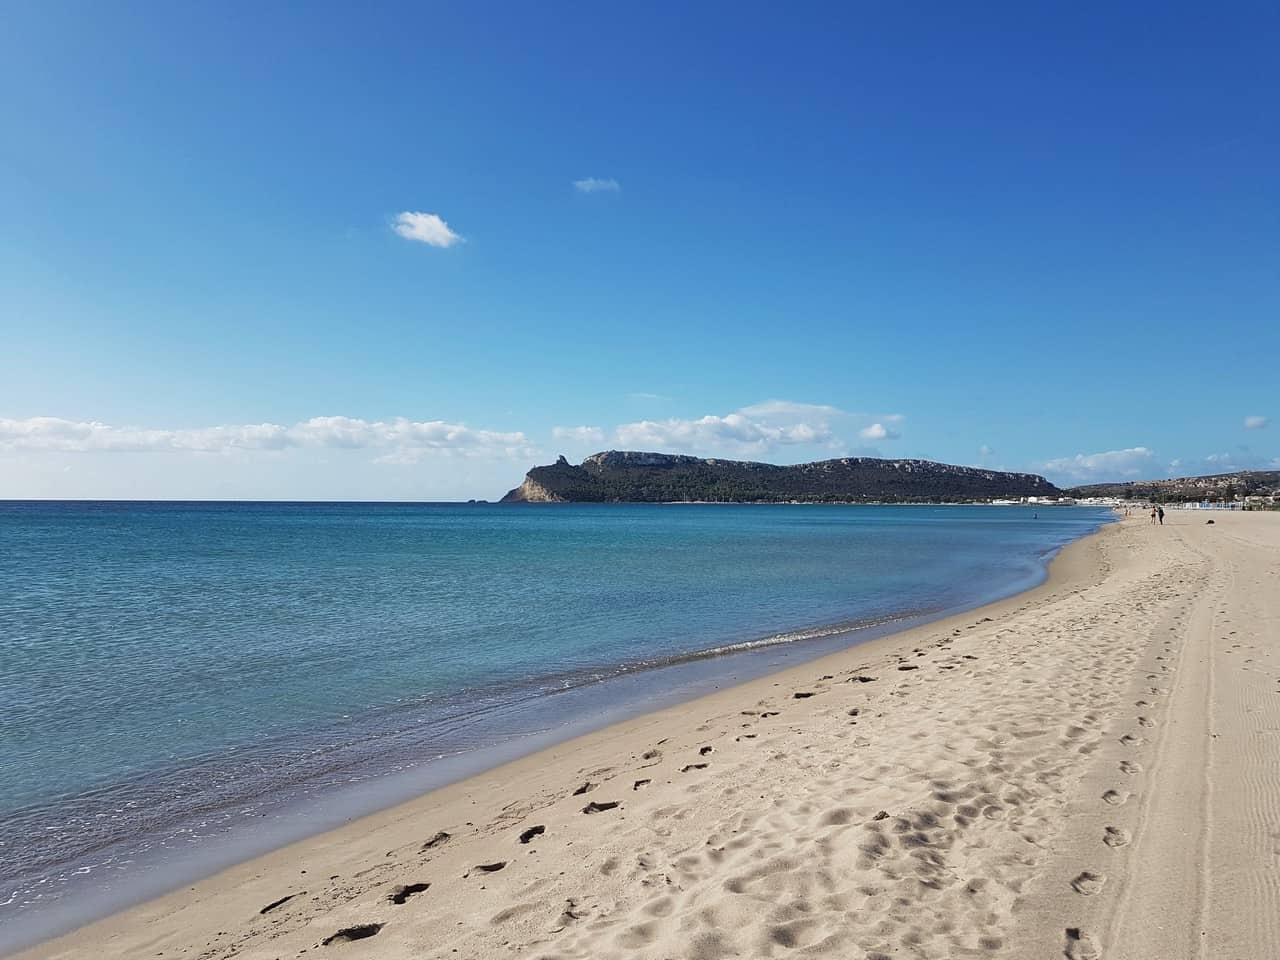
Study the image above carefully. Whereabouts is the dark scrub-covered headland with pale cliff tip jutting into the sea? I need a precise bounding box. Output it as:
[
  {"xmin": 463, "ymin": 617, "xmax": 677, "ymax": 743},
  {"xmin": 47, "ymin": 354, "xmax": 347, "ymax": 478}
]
[{"xmin": 502, "ymin": 451, "xmax": 1061, "ymax": 503}]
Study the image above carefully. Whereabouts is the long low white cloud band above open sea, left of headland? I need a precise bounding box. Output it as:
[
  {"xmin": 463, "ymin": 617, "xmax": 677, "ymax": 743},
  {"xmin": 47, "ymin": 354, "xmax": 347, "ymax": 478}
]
[{"xmin": 0, "ymin": 416, "xmax": 534, "ymax": 462}]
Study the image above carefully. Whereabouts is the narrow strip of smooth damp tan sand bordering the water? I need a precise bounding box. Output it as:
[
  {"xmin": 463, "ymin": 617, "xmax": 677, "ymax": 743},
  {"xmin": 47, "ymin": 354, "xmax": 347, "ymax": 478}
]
[{"xmin": 3, "ymin": 521, "xmax": 1119, "ymax": 957}]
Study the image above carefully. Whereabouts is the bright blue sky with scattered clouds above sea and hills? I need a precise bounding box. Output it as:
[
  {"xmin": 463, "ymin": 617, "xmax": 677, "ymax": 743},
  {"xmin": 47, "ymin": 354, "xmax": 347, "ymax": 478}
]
[{"xmin": 0, "ymin": 0, "xmax": 1280, "ymax": 499}]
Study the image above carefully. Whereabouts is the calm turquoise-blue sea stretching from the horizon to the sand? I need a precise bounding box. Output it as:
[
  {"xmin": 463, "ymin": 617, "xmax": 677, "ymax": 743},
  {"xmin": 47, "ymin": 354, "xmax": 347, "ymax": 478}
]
[{"xmin": 0, "ymin": 503, "xmax": 1108, "ymax": 947}]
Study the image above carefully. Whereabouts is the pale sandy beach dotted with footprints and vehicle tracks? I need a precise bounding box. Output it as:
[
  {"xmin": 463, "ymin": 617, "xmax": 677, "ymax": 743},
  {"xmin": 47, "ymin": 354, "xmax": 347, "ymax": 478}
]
[{"xmin": 18, "ymin": 511, "xmax": 1280, "ymax": 960}]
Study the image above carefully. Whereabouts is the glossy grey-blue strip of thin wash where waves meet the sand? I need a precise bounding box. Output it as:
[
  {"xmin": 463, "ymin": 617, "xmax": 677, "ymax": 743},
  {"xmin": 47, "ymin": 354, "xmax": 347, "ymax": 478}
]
[{"xmin": 0, "ymin": 515, "xmax": 1110, "ymax": 955}]
